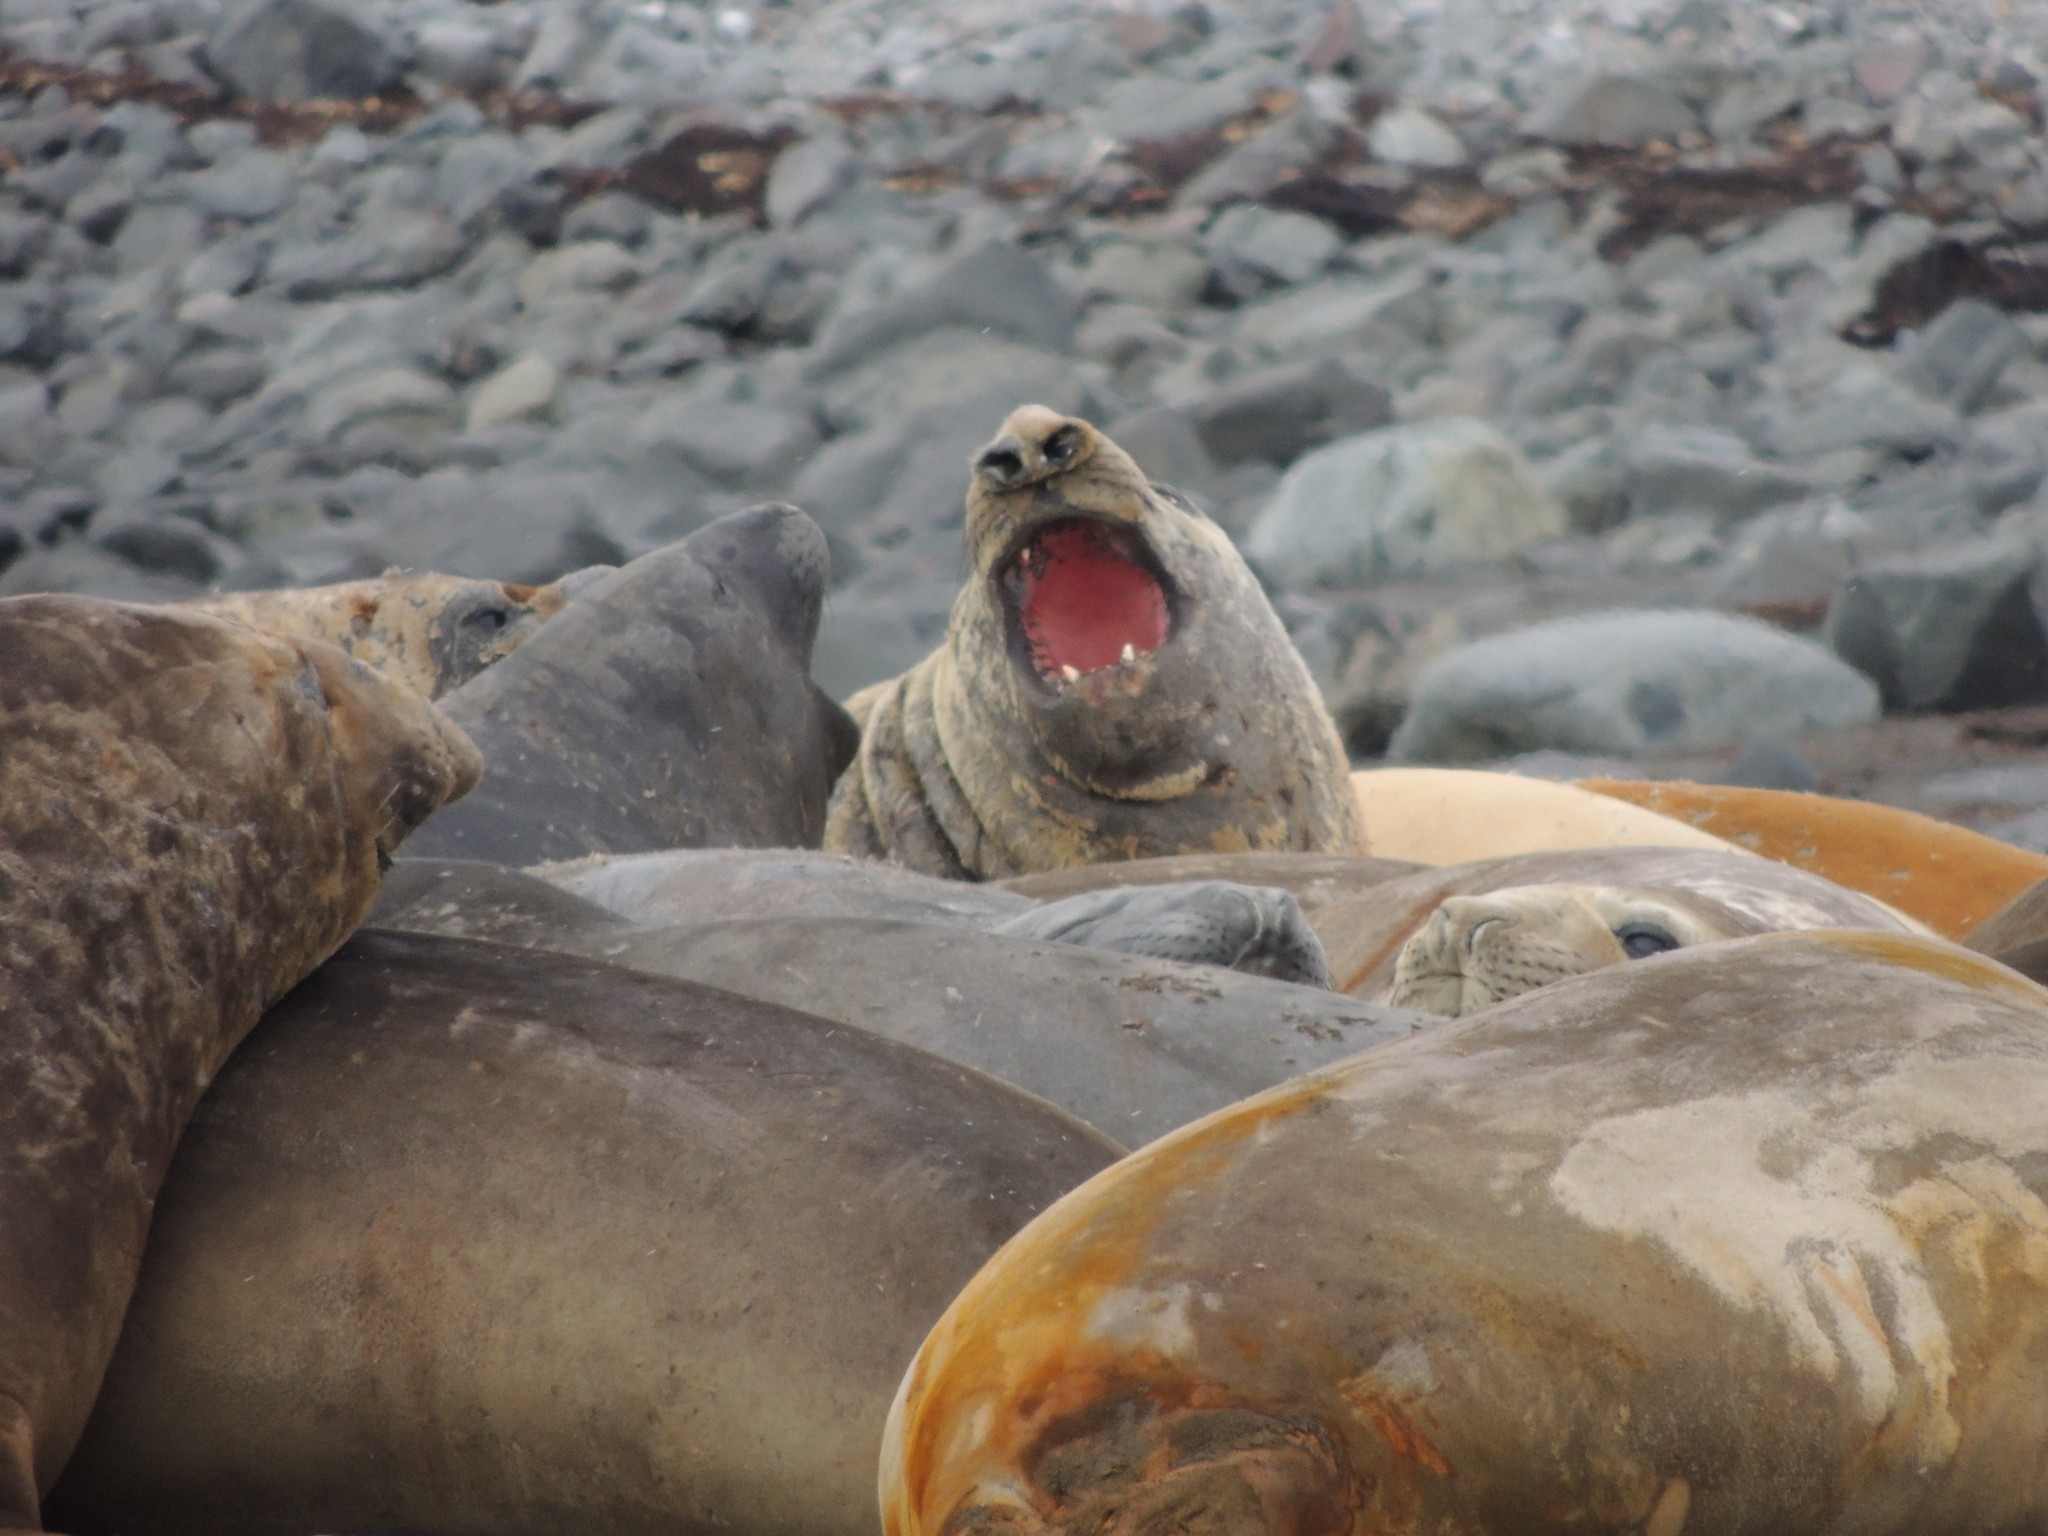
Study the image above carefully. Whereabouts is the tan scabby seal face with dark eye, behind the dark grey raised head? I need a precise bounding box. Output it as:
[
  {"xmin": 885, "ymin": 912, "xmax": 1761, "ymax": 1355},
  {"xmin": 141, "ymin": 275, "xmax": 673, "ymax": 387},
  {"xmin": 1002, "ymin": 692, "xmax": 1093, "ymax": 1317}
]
[{"xmin": 184, "ymin": 569, "xmax": 563, "ymax": 698}]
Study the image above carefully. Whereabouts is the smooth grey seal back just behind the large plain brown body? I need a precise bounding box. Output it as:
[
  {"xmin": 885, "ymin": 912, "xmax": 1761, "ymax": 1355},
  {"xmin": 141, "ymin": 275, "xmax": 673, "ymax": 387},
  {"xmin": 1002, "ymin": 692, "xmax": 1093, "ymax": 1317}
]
[{"xmin": 373, "ymin": 860, "xmax": 1434, "ymax": 1145}]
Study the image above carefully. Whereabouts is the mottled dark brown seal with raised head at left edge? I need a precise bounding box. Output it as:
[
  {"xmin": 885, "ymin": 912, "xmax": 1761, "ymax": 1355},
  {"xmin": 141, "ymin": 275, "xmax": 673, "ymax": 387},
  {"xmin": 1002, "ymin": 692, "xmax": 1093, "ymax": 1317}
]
[{"xmin": 0, "ymin": 596, "xmax": 479, "ymax": 1528}]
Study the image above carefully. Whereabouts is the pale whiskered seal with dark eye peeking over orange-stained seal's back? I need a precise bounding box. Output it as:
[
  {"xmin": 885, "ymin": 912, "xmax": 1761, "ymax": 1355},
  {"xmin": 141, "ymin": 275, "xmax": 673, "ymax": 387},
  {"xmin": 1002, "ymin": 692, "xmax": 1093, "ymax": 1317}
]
[{"xmin": 1311, "ymin": 848, "xmax": 1927, "ymax": 1012}]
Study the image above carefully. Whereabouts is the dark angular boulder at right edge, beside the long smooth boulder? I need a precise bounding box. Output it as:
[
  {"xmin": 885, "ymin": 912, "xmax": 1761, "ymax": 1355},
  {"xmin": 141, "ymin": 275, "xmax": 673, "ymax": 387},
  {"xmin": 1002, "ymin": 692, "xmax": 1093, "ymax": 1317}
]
[{"xmin": 1827, "ymin": 539, "xmax": 2048, "ymax": 711}]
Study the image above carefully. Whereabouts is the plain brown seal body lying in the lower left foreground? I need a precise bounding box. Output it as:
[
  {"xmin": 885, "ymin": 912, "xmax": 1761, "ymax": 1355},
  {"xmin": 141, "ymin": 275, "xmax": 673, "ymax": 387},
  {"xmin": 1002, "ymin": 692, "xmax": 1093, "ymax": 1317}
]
[{"xmin": 51, "ymin": 932, "xmax": 1120, "ymax": 1536}]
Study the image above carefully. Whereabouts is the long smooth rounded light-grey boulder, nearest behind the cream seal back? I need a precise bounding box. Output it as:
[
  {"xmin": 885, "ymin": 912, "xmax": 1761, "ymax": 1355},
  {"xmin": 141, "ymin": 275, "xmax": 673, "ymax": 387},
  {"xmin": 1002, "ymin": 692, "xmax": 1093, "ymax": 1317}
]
[{"xmin": 1389, "ymin": 612, "xmax": 1878, "ymax": 762}]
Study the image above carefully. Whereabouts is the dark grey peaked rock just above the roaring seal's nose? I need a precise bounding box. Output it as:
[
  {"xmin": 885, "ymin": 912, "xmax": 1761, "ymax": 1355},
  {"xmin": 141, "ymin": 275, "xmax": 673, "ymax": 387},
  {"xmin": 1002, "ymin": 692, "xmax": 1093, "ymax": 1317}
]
[{"xmin": 811, "ymin": 240, "xmax": 1075, "ymax": 375}]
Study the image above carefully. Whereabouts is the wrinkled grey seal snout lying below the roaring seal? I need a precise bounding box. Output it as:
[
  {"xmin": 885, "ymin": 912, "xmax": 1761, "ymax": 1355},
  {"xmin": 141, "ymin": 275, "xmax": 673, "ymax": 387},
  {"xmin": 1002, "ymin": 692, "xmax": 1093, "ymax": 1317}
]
[{"xmin": 995, "ymin": 881, "xmax": 1329, "ymax": 987}]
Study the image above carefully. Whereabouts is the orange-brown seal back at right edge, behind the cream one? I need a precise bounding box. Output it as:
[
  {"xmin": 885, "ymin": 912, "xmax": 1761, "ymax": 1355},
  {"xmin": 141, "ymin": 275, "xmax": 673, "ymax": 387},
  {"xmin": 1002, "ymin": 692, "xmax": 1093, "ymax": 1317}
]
[{"xmin": 1581, "ymin": 778, "xmax": 2048, "ymax": 940}]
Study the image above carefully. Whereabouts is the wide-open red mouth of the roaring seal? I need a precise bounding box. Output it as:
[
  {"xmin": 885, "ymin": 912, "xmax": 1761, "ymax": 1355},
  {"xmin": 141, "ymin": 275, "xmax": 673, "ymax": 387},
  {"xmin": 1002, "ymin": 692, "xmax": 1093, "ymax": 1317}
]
[{"xmin": 995, "ymin": 516, "xmax": 1174, "ymax": 692}]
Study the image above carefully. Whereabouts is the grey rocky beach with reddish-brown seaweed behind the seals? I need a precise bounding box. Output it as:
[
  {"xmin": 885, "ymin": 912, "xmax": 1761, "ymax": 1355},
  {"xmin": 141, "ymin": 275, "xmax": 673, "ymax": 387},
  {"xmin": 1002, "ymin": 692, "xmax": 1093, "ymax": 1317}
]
[{"xmin": 12, "ymin": 0, "xmax": 2048, "ymax": 848}]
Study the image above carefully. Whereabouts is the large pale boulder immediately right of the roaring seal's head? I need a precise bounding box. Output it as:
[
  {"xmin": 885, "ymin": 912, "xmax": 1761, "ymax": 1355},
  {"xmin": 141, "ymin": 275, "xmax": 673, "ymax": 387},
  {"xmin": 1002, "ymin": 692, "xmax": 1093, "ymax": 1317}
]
[{"xmin": 1245, "ymin": 418, "xmax": 1569, "ymax": 586}]
